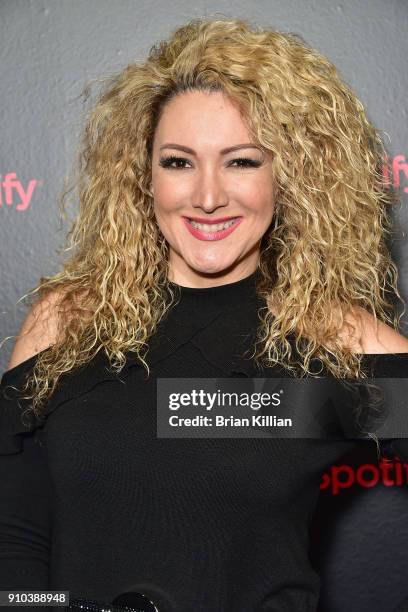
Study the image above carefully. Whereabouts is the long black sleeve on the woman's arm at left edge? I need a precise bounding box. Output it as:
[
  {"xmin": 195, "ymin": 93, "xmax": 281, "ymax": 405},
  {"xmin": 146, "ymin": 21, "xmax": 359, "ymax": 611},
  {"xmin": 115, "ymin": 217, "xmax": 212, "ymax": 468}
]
[{"xmin": 0, "ymin": 356, "xmax": 52, "ymax": 592}]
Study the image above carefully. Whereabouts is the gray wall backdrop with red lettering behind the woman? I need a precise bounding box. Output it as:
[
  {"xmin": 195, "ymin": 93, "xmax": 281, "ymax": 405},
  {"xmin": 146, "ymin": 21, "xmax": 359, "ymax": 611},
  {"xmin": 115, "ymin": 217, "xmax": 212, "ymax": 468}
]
[{"xmin": 0, "ymin": 0, "xmax": 408, "ymax": 612}]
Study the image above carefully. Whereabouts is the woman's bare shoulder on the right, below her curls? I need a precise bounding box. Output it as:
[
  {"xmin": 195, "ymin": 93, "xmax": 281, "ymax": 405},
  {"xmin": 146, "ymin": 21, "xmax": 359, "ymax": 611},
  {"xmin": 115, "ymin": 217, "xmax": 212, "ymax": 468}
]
[{"xmin": 341, "ymin": 307, "xmax": 408, "ymax": 354}]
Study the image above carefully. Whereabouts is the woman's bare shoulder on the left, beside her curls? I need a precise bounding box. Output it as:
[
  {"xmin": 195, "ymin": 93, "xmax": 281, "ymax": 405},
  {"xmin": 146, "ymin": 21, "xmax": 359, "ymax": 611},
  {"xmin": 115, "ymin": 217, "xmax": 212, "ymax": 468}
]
[{"xmin": 8, "ymin": 291, "xmax": 66, "ymax": 369}]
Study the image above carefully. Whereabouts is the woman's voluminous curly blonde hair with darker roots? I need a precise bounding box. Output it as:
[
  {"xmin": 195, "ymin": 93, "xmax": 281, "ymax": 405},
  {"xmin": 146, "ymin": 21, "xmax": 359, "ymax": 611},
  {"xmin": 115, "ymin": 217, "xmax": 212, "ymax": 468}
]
[{"xmin": 0, "ymin": 18, "xmax": 402, "ymax": 436}]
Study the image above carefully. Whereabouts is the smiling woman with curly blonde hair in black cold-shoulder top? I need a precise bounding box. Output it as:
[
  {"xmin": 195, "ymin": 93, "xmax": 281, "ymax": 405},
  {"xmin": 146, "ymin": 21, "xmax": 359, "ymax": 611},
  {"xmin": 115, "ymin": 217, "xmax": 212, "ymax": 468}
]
[{"xmin": 0, "ymin": 14, "xmax": 408, "ymax": 612}]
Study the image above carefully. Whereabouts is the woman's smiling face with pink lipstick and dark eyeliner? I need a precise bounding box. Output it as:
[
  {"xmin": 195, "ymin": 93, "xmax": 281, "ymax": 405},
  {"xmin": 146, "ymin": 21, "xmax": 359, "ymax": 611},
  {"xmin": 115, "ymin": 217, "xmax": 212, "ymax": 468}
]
[{"xmin": 151, "ymin": 91, "xmax": 274, "ymax": 287}]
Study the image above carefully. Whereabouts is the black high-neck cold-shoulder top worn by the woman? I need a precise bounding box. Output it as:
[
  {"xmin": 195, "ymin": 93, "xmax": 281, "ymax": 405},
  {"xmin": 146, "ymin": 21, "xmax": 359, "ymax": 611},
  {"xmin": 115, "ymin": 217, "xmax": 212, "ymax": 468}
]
[{"xmin": 0, "ymin": 273, "xmax": 408, "ymax": 612}]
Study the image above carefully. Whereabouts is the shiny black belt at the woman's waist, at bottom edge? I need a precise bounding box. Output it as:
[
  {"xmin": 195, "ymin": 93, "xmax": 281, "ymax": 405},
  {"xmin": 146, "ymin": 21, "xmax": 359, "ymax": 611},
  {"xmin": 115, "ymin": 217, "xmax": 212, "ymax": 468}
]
[{"xmin": 65, "ymin": 591, "xmax": 161, "ymax": 612}]
